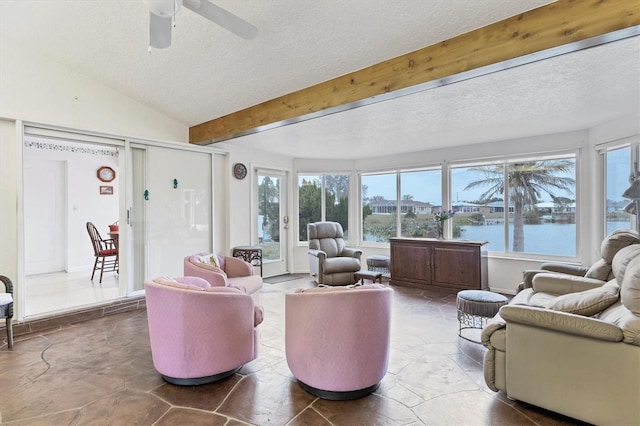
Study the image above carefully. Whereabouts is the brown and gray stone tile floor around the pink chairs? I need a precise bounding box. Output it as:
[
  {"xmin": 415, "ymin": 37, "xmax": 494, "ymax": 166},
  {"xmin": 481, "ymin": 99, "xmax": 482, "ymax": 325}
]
[{"xmin": 0, "ymin": 276, "xmax": 580, "ymax": 426}]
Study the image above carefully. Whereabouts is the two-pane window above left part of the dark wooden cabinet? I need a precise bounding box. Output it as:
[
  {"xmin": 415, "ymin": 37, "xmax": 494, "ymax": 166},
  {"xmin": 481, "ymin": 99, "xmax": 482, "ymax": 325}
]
[{"xmin": 361, "ymin": 169, "xmax": 442, "ymax": 243}]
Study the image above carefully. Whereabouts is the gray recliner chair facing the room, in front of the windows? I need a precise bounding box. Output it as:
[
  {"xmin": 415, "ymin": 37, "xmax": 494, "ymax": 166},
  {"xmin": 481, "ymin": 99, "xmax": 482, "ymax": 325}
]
[{"xmin": 307, "ymin": 222, "xmax": 362, "ymax": 285}]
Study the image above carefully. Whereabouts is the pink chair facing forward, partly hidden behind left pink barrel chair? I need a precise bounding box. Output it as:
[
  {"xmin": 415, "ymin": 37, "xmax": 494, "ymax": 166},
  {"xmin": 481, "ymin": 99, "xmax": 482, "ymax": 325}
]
[{"xmin": 184, "ymin": 253, "xmax": 262, "ymax": 304}]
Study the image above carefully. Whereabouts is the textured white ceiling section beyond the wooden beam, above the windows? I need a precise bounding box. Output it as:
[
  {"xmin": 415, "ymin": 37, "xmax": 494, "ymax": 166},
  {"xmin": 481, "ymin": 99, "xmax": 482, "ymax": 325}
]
[{"xmin": 232, "ymin": 37, "xmax": 640, "ymax": 159}]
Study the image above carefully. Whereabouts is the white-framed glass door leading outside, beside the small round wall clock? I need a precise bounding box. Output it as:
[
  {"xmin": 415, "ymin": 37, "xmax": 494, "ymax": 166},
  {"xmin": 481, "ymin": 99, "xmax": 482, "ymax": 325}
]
[{"xmin": 255, "ymin": 170, "xmax": 289, "ymax": 277}]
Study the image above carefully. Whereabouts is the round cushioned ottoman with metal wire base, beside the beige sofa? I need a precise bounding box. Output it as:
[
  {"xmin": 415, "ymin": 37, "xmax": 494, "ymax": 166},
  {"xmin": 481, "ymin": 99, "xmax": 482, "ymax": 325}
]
[{"xmin": 456, "ymin": 290, "xmax": 509, "ymax": 343}]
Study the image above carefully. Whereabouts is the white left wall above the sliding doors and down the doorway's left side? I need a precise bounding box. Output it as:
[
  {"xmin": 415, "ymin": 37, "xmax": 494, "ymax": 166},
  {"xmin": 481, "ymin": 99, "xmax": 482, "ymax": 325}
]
[{"xmin": 0, "ymin": 37, "xmax": 189, "ymax": 317}]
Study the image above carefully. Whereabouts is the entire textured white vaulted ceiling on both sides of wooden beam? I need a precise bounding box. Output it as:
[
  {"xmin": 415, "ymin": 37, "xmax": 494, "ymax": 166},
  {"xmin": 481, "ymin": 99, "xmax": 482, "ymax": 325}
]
[{"xmin": 0, "ymin": 0, "xmax": 640, "ymax": 158}]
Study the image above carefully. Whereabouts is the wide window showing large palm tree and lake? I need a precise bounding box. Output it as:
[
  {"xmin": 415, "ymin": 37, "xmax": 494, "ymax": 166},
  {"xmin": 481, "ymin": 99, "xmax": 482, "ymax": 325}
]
[{"xmin": 451, "ymin": 155, "xmax": 576, "ymax": 257}]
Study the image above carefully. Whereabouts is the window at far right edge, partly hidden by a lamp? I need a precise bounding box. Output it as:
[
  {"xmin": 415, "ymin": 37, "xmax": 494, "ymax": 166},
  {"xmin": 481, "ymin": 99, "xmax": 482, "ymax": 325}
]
[{"xmin": 605, "ymin": 145, "xmax": 638, "ymax": 235}]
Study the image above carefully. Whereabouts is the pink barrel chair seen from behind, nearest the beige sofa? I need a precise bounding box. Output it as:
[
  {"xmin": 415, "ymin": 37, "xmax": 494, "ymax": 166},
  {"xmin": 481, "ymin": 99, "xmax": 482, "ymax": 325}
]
[{"xmin": 285, "ymin": 284, "xmax": 393, "ymax": 400}]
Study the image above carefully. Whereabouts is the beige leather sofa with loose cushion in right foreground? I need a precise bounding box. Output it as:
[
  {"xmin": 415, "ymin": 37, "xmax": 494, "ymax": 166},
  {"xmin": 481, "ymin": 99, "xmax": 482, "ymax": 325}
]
[{"xmin": 482, "ymin": 238, "xmax": 640, "ymax": 425}]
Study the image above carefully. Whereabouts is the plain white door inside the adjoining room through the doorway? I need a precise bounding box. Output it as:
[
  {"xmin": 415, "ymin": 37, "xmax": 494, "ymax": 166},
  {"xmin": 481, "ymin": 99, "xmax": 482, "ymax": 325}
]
[{"xmin": 24, "ymin": 160, "xmax": 67, "ymax": 275}]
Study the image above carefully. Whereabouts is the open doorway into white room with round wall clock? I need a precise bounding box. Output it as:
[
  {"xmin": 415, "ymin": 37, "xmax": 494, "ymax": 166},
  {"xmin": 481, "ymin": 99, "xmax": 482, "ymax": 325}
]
[{"xmin": 21, "ymin": 133, "xmax": 122, "ymax": 318}]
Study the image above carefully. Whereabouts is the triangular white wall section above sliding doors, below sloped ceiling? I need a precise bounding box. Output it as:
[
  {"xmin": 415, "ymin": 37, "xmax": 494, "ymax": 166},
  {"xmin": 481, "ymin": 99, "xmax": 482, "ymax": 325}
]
[{"xmin": 0, "ymin": 37, "xmax": 189, "ymax": 142}]
